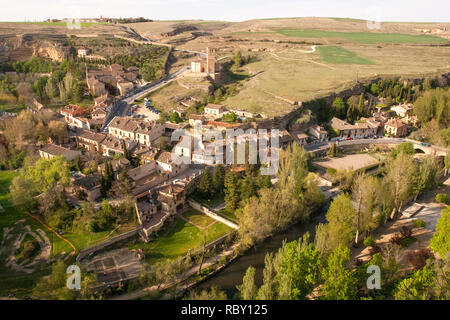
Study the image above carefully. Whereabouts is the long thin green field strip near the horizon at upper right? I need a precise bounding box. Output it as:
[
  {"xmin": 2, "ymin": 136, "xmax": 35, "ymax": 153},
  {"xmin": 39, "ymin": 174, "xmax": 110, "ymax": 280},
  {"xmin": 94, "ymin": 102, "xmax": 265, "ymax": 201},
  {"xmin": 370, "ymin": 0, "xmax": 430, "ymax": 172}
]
[{"xmin": 276, "ymin": 29, "xmax": 447, "ymax": 44}]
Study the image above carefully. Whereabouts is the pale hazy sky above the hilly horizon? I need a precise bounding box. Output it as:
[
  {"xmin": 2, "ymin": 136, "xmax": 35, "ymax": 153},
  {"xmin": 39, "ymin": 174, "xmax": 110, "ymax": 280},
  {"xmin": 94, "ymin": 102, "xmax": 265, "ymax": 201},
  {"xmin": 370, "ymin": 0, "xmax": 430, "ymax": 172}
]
[{"xmin": 0, "ymin": 0, "xmax": 450, "ymax": 22}]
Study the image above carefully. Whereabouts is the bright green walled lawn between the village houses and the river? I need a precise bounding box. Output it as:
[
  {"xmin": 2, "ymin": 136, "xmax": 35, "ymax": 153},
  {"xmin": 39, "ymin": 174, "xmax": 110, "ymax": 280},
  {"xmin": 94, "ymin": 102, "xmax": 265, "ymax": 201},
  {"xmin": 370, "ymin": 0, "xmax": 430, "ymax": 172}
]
[{"xmin": 132, "ymin": 218, "xmax": 232, "ymax": 264}]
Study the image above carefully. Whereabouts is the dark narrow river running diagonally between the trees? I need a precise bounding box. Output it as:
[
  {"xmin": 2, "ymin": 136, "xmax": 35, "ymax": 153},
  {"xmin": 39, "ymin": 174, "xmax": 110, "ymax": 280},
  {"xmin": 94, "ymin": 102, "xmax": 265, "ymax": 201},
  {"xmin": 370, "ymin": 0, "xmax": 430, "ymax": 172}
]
[{"xmin": 197, "ymin": 206, "xmax": 328, "ymax": 299}]
